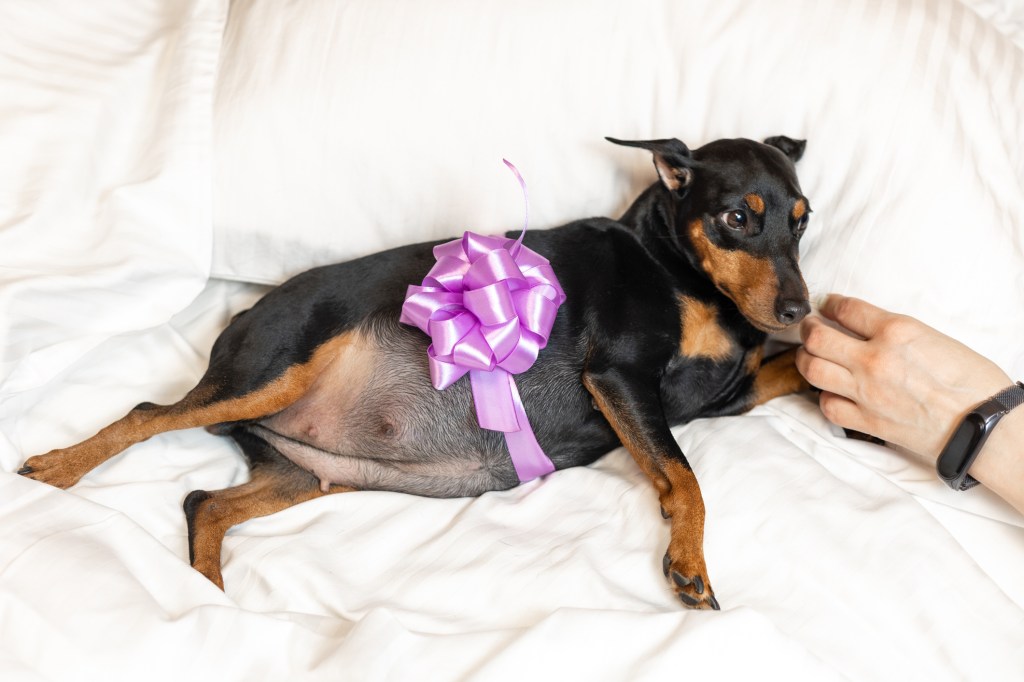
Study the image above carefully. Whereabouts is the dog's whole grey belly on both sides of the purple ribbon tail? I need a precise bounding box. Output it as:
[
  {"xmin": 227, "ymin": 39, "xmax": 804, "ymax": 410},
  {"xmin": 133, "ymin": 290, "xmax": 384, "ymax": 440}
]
[{"xmin": 253, "ymin": 324, "xmax": 617, "ymax": 497}]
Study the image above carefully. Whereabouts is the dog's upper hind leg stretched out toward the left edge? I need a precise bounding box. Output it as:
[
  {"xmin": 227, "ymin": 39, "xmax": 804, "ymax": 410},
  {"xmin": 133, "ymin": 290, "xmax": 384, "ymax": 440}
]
[{"xmin": 18, "ymin": 318, "xmax": 358, "ymax": 488}]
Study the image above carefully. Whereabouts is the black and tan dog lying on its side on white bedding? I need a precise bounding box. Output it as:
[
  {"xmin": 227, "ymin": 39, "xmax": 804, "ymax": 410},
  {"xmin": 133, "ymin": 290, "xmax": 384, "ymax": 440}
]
[{"xmin": 19, "ymin": 137, "xmax": 810, "ymax": 608}]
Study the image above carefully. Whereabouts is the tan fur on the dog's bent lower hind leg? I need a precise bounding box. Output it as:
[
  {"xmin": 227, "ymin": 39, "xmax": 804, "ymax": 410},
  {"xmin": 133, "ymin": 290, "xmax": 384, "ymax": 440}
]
[{"xmin": 185, "ymin": 469, "xmax": 354, "ymax": 590}]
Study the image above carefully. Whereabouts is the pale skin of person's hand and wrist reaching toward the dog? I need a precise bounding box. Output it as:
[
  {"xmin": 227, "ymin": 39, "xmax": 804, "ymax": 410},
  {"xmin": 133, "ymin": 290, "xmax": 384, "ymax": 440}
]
[{"xmin": 797, "ymin": 294, "xmax": 1024, "ymax": 513}]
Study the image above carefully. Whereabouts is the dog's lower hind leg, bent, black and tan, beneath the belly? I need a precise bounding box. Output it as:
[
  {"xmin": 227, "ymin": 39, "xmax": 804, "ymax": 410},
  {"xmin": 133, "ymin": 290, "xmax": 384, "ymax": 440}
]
[{"xmin": 183, "ymin": 427, "xmax": 354, "ymax": 590}]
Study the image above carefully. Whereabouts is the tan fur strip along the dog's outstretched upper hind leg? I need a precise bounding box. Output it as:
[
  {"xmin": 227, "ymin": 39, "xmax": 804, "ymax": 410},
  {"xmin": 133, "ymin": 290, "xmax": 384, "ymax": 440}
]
[{"xmin": 25, "ymin": 333, "xmax": 360, "ymax": 488}]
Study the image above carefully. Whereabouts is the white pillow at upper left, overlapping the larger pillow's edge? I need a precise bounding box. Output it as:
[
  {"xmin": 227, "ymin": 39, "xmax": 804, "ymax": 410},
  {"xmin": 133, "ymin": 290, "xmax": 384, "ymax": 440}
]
[{"xmin": 0, "ymin": 0, "xmax": 227, "ymax": 391}]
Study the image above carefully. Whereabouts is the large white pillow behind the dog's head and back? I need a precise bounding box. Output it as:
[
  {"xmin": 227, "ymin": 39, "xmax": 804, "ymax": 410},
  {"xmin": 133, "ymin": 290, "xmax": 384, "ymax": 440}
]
[{"xmin": 214, "ymin": 0, "xmax": 1024, "ymax": 377}]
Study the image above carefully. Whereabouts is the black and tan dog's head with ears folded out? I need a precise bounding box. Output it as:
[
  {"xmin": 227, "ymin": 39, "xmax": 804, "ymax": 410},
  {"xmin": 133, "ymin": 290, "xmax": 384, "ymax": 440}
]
[{"xmin": 608, "ymin": 136, "xmax": 811, "ymax": 332}]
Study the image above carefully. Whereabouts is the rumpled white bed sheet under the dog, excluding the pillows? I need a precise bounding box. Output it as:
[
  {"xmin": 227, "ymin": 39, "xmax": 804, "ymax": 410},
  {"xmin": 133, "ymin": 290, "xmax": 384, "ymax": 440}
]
[{"xmin": 0, "ymin": 281, "xmax": 1024, "ymax": 680}]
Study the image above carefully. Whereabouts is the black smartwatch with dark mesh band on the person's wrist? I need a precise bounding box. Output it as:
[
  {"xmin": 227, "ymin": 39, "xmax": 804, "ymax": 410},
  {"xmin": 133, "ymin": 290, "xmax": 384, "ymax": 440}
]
[{"xmin": 935, "ymin": 382, "xmax": 1024, "ymax": 491}]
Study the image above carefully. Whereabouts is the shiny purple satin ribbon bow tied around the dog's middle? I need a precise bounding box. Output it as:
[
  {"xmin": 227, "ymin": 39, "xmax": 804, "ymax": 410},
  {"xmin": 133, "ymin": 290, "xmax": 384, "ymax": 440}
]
[{"xmin": 399, "ymin": 161, "xmax": 565, "ymax": 482}]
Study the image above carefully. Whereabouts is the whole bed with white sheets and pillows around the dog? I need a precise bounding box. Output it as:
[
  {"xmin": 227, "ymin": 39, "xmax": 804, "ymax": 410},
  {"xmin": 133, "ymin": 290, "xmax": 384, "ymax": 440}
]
[{"xmin": 0, "ymin": 0, "xmax": 1024, "ymax": 681}]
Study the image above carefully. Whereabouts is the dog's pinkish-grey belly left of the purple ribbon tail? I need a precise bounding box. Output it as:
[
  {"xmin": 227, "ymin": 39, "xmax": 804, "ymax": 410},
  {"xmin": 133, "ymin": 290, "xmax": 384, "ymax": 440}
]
[{"xmin": 254, "ymin": 323, "xmax": 517, "ymax": 497}]
